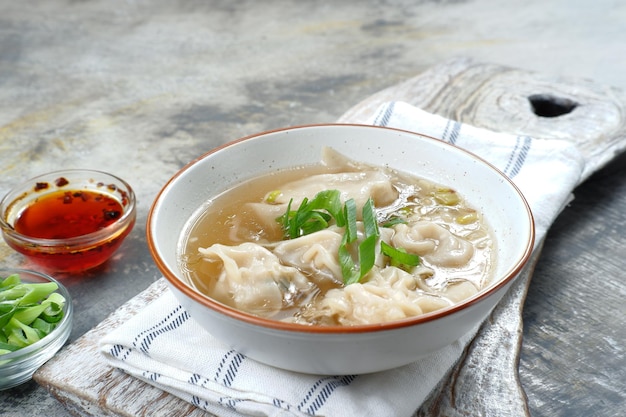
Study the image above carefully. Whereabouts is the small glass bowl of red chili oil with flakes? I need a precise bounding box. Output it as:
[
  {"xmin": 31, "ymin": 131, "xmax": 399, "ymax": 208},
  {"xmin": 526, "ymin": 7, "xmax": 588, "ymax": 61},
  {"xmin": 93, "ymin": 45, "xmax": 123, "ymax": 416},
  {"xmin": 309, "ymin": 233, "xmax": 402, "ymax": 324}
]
[{"xmin": 0, "ymin": 169, "xmax": 136, "ymax": 273}]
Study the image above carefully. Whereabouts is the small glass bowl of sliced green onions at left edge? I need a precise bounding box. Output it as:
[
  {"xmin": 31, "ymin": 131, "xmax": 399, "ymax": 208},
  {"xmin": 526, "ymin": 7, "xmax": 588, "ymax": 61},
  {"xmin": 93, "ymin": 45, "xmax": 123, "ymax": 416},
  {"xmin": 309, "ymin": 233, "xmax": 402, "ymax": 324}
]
[{"xmin": 0, "ymin": 269, "xmax": 73, "ymax": 390}]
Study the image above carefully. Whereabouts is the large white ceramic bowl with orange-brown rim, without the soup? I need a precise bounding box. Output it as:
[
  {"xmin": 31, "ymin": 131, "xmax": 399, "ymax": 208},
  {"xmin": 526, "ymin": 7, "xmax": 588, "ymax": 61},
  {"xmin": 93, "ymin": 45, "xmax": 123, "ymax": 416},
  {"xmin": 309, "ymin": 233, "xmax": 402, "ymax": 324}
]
[{"xmin": 147, "ymin": 125, "xmax": 534, "ymax": 375}]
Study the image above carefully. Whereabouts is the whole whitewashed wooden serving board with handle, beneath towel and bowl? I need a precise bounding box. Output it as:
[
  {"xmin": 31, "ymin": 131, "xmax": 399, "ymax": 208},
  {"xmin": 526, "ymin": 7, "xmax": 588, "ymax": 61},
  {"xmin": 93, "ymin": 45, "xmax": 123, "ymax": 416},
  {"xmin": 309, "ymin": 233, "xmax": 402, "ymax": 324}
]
[{"xmin": 35, "ymin": 59, "xmax": 626, "ymax": 417}]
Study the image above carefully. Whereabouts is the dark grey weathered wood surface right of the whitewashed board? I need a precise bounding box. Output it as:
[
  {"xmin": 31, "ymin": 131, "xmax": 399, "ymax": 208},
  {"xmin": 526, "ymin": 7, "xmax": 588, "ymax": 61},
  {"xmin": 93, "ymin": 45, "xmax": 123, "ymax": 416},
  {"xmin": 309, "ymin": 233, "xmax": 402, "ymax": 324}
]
[{"xmin": 519, "ymin": 150, "xmax": 626, "ymax": 417}]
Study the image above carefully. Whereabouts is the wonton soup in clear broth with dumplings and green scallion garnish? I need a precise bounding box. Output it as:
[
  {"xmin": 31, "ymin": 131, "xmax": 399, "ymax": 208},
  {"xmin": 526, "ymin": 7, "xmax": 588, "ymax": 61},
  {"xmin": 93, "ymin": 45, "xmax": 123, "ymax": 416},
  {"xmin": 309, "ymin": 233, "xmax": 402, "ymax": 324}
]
[{"xmin": 179, "ymin": 149, "xmax": 495, "ymax": 326}]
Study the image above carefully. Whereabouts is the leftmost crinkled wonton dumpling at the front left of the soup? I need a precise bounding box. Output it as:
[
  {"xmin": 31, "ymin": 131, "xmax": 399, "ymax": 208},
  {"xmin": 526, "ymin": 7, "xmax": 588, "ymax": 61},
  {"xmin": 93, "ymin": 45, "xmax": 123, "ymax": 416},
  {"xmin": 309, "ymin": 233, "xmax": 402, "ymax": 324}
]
[{"xmin": 199, "ymin": 243, "xmax": 311, "ymax": 317}]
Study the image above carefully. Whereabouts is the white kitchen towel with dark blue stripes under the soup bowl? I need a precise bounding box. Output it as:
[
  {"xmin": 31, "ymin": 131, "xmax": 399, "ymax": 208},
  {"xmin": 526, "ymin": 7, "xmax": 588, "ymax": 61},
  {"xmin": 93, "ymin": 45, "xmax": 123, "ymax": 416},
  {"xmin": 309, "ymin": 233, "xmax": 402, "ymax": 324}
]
[{"xmin": 101, "ymin": 102, "xmax": 584, "ymax": 417}]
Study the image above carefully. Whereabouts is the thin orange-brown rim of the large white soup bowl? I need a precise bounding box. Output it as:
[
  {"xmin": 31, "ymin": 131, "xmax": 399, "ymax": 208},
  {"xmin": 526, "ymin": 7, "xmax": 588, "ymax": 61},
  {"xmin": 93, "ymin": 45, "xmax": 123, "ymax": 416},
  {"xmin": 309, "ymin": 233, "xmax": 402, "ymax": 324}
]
[{"xmin": 146, "ymin": 123, "xmax": 535, "ymax": 334}]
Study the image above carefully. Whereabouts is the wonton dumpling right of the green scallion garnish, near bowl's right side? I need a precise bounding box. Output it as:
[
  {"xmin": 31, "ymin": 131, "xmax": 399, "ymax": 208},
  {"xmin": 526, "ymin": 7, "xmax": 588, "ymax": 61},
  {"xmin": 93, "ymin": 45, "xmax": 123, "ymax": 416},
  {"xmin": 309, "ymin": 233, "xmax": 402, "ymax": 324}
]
[{"xmin": 392, "ymin": 221, "xmax": 474, "ymax": 267}]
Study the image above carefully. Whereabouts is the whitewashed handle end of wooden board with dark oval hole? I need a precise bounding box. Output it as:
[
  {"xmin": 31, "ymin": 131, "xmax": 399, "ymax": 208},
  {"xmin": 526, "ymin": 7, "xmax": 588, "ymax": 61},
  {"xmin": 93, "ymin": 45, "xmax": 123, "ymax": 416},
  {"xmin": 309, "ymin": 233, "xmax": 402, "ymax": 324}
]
[{"xmin": 340, "ymin": 58, "xmax": 626, "ymax": 180}]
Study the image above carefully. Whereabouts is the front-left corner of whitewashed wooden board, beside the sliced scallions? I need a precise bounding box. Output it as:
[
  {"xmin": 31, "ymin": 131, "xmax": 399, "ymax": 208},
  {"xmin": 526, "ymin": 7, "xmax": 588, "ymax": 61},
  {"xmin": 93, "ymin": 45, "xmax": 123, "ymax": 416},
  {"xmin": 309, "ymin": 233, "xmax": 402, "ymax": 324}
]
[{"xmin": 34, "ymin": 279, "xmax": 207, "ymax": 417}]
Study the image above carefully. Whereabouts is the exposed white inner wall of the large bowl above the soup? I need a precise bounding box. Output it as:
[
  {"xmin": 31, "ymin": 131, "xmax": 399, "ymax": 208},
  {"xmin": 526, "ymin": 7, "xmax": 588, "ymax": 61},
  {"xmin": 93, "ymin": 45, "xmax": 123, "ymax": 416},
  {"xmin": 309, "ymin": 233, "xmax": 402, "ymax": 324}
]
[{"xmin": 147, "ymin": 125, "xmax": 534, "ymax": 324}]
